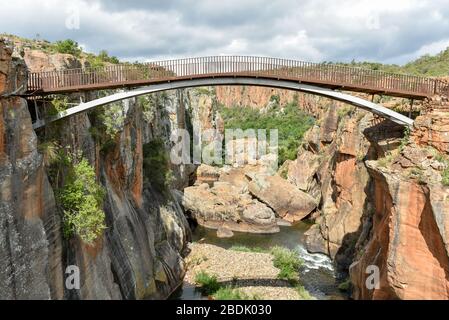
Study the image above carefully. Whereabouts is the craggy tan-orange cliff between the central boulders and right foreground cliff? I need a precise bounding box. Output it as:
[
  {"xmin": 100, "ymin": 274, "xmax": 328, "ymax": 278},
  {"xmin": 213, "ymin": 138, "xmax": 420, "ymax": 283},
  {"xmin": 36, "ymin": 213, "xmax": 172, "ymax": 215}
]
[{"xmin": 286, "ymin": 104, "xmax": 372, "ymax": 269}]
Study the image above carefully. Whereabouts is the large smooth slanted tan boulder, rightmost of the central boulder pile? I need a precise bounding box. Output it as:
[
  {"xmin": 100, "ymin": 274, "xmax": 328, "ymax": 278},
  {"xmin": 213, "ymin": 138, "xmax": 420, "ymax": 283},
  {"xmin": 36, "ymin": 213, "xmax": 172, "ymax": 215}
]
[{"xmin": 249, "ymin": 175, "xmax": 317, "ymax": 222}]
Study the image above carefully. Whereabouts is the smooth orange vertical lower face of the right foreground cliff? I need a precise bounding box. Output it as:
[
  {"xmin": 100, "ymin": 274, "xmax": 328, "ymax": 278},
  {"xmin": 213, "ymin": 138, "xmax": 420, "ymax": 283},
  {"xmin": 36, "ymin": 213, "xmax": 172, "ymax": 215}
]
[{"xmin": 350, "ymin": 165, "xmax": 449, "ymax": 300}]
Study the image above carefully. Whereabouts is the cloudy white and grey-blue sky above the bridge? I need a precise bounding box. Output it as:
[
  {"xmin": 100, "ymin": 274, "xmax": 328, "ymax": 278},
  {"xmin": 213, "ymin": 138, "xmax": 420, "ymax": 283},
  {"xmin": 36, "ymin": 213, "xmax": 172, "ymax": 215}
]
[{"xmin": 0, "ymin": 0, "xmax": 449, "ymax": 64}]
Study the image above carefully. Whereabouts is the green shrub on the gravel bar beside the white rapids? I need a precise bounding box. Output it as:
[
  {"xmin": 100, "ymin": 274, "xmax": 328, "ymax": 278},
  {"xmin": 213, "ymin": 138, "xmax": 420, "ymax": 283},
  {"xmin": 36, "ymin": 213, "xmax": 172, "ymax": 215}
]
[{"xmin": 271, "ymin": 247, "xmax": 302, "ymax": 282}]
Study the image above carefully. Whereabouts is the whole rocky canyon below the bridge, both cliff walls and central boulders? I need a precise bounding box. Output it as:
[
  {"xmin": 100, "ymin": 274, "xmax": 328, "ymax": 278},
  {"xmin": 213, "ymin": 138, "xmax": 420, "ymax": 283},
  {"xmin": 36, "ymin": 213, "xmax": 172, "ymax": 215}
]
[{"xmin": 0, "ymin": 37, "xmax": 449, "ymax": 300}]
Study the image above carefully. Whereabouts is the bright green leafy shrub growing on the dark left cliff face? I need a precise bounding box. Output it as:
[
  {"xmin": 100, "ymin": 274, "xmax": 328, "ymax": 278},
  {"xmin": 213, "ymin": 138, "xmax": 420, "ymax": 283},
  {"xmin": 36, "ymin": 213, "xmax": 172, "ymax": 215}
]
[{"xmin": 58, "ymin": 159, "xmax": 106, "ymax": 244}]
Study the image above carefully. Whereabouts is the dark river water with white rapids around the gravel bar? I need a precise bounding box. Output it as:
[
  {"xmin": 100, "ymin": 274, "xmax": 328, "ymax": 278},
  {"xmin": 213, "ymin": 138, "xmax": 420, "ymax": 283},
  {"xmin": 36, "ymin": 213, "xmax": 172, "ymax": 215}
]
[{"xmin": 171, "ymin": 223, "xmax": 346, "ymax": 300}]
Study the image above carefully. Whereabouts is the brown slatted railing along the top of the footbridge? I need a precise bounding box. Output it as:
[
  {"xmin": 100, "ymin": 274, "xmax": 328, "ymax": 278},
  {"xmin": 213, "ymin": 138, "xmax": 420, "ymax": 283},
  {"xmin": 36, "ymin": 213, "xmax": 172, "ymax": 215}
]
[{"xmin": 28, "ymin": 56, "xmax": 442, "ymax": 96}]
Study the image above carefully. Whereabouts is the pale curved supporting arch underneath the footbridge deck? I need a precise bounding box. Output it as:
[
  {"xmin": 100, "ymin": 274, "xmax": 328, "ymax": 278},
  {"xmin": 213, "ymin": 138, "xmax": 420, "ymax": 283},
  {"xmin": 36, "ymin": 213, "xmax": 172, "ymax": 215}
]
[{"xmin": 33, "ymin": 77, "xmax": 413, "ymax": 129}]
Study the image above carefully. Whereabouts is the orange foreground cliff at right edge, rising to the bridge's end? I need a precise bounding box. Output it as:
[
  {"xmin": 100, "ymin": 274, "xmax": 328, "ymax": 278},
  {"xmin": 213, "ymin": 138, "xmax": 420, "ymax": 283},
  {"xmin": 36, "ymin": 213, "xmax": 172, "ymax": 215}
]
[{"xmin": 350, "ymin": 101, "xmax": 449, "ymax": 300}]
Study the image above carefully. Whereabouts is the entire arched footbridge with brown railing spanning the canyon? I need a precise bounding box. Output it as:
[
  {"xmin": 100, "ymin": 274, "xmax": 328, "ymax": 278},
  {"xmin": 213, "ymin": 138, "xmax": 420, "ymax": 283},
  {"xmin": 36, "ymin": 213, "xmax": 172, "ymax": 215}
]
[{"xmin": 25, "ymin": 56, "xmax": 447, "ymax": 128}]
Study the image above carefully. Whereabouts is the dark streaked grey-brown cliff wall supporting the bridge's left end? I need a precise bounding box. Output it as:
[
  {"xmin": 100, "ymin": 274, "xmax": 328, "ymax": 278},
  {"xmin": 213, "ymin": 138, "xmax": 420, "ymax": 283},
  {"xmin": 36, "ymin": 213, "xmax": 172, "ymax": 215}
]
[{"xmin": 0, "ymin": 43, "xmax": 191, "ymax": 299}]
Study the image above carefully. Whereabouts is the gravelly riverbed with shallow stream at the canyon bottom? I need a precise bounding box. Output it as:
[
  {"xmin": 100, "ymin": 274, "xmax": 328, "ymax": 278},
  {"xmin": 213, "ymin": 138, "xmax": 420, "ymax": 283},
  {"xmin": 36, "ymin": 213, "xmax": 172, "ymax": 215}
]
[{"xmin": 171, "ymin": 223, "xmax": 346, "ymax": 300}]
